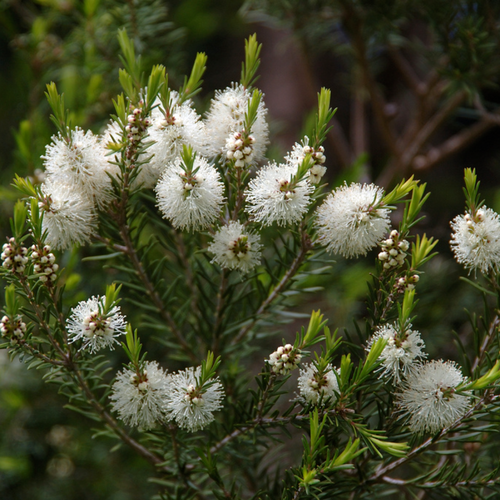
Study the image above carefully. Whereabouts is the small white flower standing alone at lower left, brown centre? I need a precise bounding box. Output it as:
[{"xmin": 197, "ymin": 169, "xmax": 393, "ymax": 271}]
[{"xmin": 67, "ymin": 297, "xmax": 127, "ymax": 353}]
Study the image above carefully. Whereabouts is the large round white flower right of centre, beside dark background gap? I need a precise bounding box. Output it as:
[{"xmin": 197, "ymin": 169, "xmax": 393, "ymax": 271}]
[{"xmin": 316, "ymin": 183, "xmax": 390, "ymax": 258}]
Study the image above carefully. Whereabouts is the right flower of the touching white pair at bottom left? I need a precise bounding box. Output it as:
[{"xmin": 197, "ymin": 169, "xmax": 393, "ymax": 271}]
[{"xmin": 164, "ymin": 366, "xmax": 224, "ymax": 432}]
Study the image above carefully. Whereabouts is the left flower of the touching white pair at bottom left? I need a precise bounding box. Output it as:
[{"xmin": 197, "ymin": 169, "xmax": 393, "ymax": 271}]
[{"xmin": 110, "ymin": 361, "xmax": 169, "ymax": 430}]
